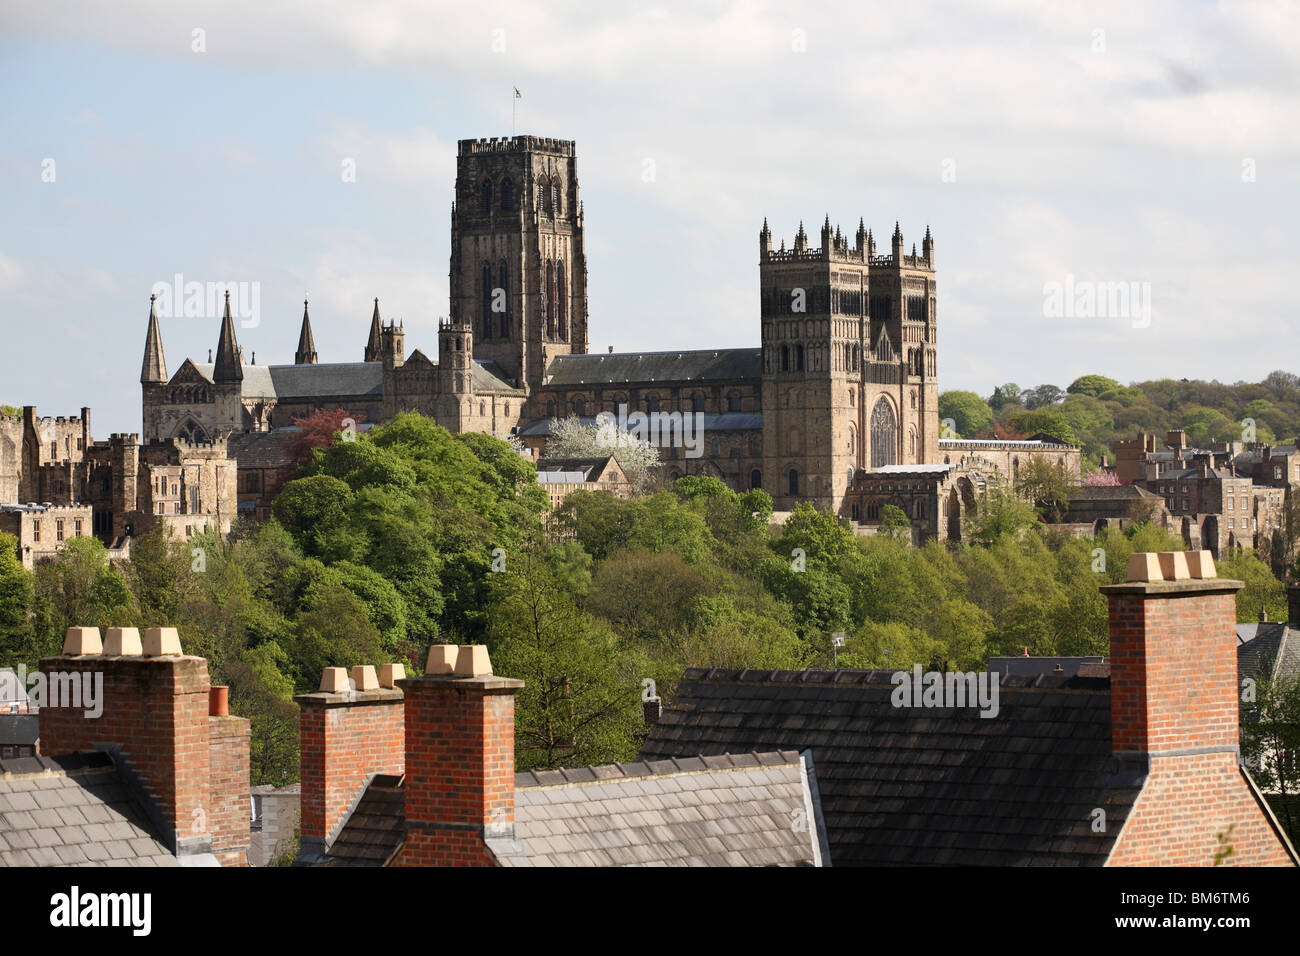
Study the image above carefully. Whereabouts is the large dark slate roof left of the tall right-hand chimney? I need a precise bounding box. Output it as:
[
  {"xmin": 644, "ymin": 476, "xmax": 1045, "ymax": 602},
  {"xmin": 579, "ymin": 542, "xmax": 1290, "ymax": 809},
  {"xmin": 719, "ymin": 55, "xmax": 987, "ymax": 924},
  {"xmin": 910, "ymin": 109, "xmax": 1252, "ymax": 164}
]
[{"xmin": 641, "ymin": 669, "xmax": 1143, "ymax": 866}]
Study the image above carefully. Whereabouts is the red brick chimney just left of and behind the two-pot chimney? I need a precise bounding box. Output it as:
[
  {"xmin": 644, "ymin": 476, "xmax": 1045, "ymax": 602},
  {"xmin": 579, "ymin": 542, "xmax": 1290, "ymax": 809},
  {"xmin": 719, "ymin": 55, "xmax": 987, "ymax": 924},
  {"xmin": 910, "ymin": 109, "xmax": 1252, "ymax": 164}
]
[{"xmin": 294, "ymin": 665, "xmax": 406, "ymax": 862}]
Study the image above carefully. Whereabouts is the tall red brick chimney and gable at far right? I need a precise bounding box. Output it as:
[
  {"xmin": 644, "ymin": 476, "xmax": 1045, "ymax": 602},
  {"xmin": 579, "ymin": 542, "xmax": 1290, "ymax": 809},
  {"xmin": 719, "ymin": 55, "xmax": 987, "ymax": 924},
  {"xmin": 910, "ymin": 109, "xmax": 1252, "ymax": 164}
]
[{"xmin": 1101, "ymin": 551, "xmax": 1295, "ymax": 866}]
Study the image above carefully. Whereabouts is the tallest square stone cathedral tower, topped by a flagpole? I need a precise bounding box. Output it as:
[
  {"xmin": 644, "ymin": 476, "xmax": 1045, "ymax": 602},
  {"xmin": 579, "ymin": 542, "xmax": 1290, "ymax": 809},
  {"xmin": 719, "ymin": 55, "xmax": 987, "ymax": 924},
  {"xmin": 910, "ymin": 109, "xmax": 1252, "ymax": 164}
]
[{"xmin": 450, "ymin": 137, "xmax": 588, "ymax": 393}]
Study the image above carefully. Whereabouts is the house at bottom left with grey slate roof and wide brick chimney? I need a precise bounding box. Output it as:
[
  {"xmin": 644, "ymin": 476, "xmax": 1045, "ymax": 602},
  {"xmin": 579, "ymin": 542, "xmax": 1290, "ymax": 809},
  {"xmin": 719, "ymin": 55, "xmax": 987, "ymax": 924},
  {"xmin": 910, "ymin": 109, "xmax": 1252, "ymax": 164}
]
[{"xmin": 0, "ymin": 627, "xmax": 250, "ymax": 866}]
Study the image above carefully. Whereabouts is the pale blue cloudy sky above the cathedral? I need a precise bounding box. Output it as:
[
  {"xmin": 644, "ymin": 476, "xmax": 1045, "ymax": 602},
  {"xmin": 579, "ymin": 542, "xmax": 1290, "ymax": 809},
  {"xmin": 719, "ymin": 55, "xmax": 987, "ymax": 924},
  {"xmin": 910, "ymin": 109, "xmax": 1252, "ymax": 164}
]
[{"xmin": 0, "ymin": 0, "xmax": 1300, "ymax": 438}]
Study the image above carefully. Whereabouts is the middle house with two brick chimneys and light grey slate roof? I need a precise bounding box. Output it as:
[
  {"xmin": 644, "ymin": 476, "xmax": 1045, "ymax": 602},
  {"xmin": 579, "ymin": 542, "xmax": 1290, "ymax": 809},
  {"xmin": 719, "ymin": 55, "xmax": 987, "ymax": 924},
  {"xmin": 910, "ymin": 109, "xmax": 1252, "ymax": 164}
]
[{"xmin": 295, "ymin": 645, "xmax": 829, "ymax": 866}]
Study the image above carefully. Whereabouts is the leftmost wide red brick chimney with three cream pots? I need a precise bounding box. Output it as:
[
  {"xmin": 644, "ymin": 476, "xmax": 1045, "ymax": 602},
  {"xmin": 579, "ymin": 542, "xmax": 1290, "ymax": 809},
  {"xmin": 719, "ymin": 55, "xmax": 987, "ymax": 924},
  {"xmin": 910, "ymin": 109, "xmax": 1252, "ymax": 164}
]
[{"xmin": 40, "ymin": 627, "xmax": 250, "ymax": 866}]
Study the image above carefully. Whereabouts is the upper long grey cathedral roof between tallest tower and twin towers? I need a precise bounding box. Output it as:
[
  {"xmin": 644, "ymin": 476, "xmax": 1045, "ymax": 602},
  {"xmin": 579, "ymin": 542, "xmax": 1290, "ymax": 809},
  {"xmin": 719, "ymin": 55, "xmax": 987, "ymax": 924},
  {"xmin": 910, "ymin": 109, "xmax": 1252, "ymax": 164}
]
[{"xmin": 546, "ymin": 349, "xmax": 763, "ymax": 386}]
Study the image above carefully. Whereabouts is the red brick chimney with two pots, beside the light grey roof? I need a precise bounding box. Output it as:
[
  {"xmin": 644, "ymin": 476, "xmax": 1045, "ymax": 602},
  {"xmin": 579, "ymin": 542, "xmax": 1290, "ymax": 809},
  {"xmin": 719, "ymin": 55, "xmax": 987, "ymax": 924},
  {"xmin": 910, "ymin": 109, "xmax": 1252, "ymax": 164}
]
[{"xmin": 397, "ymin": 644, "xmax": 524, "ymax": 866}]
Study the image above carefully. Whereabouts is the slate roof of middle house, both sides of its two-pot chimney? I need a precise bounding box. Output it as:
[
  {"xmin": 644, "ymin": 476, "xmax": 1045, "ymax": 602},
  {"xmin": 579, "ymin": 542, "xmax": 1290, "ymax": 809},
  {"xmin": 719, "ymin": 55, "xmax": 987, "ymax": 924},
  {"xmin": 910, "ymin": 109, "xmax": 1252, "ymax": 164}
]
[{"xmin": 324, "ymin": 750, "xmax": 831, "ymax": 866}]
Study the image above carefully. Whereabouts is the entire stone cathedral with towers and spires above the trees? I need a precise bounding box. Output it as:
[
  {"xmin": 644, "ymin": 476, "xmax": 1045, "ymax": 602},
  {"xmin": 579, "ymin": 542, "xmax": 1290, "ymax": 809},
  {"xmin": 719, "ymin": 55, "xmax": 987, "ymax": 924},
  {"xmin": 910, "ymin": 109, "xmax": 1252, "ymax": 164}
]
[{"xmin": 140, "ymin": 137, "xmax": 1079, "ymax": 538}]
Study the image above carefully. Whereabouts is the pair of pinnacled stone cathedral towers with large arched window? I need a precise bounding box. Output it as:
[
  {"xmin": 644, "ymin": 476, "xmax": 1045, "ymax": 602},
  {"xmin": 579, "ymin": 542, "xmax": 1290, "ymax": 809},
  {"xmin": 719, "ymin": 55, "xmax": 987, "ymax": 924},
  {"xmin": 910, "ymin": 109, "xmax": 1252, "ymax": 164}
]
[{"xmin": 759, "ymin": 216, "xmax": 939, "ymax": 510}]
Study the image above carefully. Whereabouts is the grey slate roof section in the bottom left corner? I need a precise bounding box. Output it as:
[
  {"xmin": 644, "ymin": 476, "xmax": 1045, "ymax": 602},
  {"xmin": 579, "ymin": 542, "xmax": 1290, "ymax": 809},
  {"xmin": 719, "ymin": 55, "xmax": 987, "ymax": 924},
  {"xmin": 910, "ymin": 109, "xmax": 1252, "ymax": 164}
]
[{"xmin": 0, "ymin": 753, "xmax": 178, "ymax": 866}]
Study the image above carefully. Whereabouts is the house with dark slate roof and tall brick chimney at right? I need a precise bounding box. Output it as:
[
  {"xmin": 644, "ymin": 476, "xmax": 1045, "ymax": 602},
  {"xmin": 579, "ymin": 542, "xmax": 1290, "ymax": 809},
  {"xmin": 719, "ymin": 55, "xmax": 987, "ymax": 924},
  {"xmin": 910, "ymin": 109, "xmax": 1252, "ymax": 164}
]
[{"xmin": 640, "ymin": 551, "xmax": 1297, "ymax": 866}]
